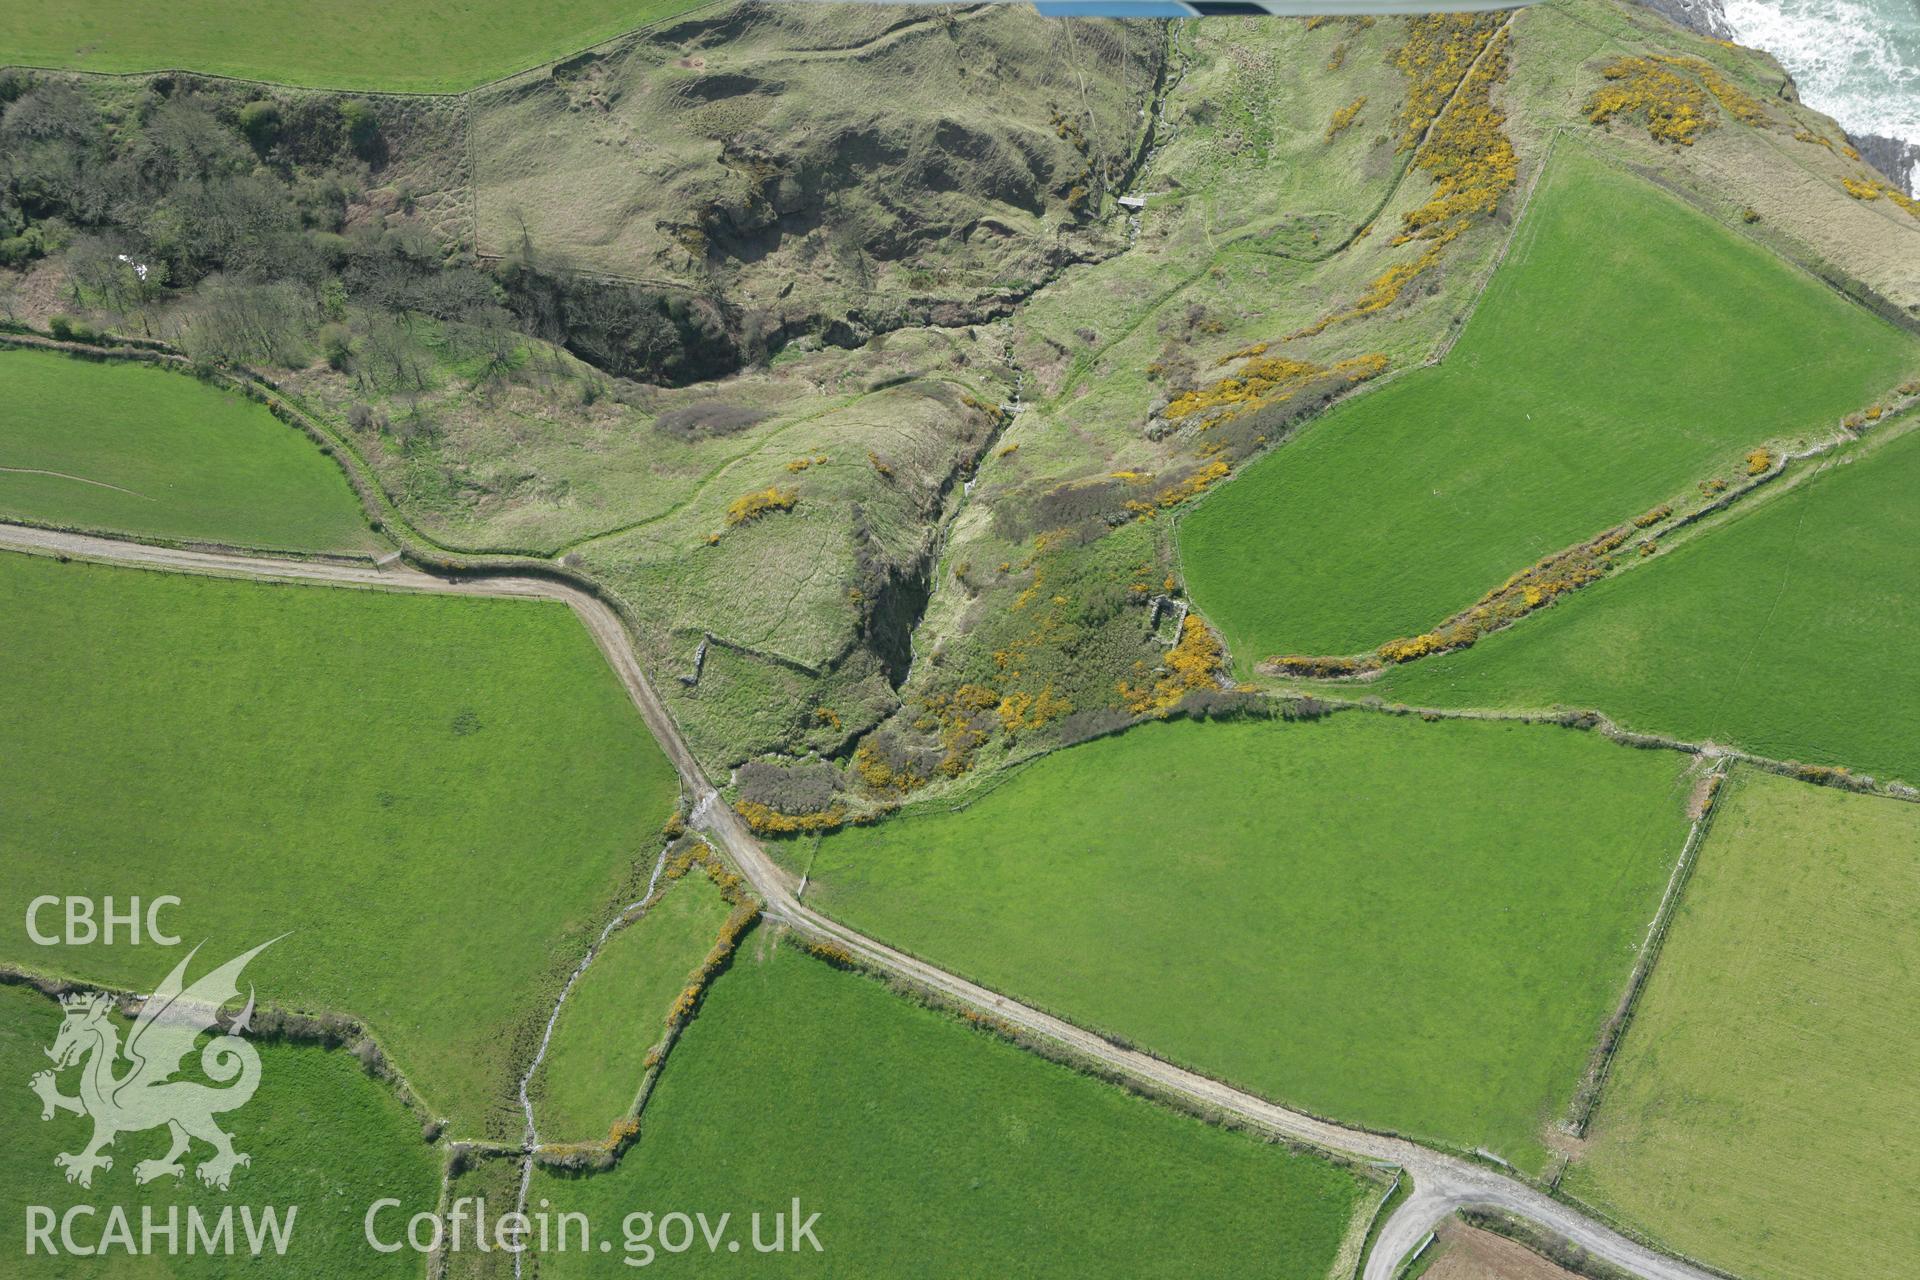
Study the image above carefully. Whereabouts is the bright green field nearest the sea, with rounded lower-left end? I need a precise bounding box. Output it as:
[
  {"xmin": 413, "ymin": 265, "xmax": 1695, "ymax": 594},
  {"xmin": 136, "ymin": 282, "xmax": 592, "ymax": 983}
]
[{"xmin": 1181, "ymin": 146, "xmax": 1920, "ymax": 672}]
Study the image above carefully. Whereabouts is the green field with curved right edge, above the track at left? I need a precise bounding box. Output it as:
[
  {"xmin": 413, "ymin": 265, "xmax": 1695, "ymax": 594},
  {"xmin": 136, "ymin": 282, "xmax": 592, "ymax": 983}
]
[{"xmin": 0, "ymin": 347, "xmax": 378, "ymax": 551}]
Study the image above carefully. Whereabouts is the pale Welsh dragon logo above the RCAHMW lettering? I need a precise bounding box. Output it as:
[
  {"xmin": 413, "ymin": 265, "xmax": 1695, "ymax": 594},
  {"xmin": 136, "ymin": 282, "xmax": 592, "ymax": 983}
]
[{"xmin": 33, "ymin": 938, "xmax": 278, "ymax": 1192}]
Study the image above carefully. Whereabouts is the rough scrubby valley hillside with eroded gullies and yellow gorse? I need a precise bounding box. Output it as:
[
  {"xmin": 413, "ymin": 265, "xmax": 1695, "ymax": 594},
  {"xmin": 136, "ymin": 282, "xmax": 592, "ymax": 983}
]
[{"xmin": 0, "ymin": 0, "xmax": 1920, "ymax": 802}]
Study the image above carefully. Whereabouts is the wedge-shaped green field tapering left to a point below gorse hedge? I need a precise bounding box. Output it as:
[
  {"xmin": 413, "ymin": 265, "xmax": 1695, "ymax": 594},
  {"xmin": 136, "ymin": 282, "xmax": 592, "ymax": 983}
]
[{"xmin": 1375, "ymin": 432, "xmax": 1920, "ymax": 783}]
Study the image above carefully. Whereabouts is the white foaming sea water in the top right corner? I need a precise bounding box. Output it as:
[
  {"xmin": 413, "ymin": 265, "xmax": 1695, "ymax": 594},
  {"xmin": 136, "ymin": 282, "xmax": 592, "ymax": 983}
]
[{"xmin": 1722, "ymin": 0, "xmax": 1920, "ymax": 184}]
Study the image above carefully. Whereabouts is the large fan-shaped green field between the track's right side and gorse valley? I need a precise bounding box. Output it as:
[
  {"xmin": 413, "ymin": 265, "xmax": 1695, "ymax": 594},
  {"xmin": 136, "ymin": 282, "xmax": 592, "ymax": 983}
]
[{"xmin": 808, "ymin": 712, "xmax": 1686, "ymax": 1167}]
